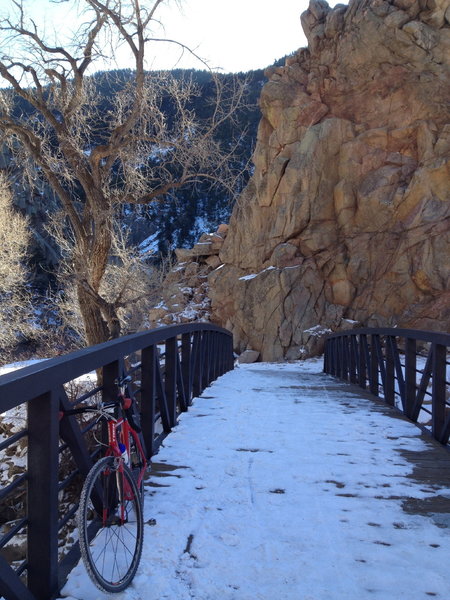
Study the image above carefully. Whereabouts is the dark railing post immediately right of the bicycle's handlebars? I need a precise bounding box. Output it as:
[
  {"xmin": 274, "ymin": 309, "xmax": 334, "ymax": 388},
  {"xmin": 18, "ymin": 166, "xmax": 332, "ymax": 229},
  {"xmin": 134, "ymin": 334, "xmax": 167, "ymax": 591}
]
[{"xmin": 141, "ymin": 346, "xmax": 157, "ymax": 458}]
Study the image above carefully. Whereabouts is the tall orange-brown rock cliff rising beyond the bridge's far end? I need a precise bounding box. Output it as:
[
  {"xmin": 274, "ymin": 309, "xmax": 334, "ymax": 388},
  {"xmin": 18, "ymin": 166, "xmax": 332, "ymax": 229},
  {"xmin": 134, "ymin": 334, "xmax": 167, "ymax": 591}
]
[{"xmin": 209, "ymin": 0, "xmax": 450, "ymax": 360}]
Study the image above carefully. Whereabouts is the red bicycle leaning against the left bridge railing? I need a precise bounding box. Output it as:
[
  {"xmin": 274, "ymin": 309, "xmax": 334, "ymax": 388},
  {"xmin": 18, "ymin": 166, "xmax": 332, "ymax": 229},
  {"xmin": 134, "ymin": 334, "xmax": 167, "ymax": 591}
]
[{"xmin": 59, "ymin": 376, "xmax": 147, "ymax": 593}]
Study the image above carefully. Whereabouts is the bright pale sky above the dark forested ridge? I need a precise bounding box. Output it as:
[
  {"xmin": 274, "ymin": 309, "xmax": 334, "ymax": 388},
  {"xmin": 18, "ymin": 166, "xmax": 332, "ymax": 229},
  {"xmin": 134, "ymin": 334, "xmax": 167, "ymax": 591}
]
[{"xmin": 7, "ymin": 0, "xmax": 344, "ymax": 72}]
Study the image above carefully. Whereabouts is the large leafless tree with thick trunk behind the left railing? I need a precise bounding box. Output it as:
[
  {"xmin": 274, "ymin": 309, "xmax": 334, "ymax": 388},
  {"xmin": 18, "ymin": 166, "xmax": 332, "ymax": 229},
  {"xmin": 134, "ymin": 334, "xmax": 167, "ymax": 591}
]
[{"xmin": 0, "ymin": 0, "xmax": 244, "ymax": 344}]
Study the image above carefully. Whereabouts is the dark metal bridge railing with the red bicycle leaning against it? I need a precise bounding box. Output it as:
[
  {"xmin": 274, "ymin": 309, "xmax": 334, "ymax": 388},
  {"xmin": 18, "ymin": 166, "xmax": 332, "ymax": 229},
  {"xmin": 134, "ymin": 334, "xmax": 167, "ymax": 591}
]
[{"xmin": 0, "ymin": 323, "xmax": 233, "ymax": 600}]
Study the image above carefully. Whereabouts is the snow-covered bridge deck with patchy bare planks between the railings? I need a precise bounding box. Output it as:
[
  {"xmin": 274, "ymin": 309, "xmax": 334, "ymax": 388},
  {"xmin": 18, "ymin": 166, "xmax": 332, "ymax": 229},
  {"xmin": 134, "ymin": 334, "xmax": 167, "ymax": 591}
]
[{"xmin": 62, "ymin": 361, "xmax": 450, "ymax": 600}]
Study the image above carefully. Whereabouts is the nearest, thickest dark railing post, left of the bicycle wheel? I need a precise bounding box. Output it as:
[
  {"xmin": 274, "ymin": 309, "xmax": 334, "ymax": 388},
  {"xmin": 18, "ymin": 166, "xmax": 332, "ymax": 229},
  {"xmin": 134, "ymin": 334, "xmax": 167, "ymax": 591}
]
[{"xmin": 27, "ymin": 391, "xmax": 59, "ymax": 600}]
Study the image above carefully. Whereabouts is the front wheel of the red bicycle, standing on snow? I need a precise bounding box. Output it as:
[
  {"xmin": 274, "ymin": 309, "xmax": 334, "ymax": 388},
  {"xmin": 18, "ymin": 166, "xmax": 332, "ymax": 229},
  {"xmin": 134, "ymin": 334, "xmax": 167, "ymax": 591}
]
[{"xmin": 78, "ymin": 456, "xmax": 144, "ymax": 593}]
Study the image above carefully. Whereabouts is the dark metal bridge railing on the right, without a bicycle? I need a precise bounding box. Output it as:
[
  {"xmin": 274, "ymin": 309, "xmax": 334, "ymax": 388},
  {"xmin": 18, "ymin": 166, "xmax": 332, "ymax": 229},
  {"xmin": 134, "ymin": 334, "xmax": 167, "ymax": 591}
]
[{"xmin": 324, "ymin": 328, "xmax": 450, "ymax": 445}]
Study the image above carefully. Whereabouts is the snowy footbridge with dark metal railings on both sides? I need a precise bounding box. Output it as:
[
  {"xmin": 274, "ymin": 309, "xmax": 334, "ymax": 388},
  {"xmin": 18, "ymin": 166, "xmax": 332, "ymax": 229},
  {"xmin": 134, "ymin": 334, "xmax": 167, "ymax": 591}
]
[{"xmin": 0, "ymin": 324, "xmax": 450, "ymax": 600}]
